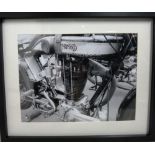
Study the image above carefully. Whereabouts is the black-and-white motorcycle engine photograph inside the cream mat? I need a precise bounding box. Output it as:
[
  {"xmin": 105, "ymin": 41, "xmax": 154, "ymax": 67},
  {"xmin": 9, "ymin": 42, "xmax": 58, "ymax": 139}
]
[{"xmin": 17, "ymin": 33, "xmax": 138, "ymax": 122}]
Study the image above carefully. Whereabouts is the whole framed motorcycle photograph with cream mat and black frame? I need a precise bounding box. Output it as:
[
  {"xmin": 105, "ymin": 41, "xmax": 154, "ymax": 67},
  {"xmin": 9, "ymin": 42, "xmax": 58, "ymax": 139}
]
[{"xmin": 0, "ymin": 13, "xmax": 155, "ymax": 141}]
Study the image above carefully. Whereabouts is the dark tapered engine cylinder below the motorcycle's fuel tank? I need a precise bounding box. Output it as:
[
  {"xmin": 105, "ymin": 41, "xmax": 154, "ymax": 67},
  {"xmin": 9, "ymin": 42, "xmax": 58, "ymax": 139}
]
[{"xmin": 63, "ymin": 56, "xmax": 89, "ymax": 101}]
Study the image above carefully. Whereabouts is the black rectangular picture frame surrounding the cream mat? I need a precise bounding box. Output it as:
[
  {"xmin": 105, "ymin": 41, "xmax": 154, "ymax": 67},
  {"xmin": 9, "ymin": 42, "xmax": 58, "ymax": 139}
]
[{"xmin": 0, "ymin": 12, "xmax": 155, "ymax": 142}]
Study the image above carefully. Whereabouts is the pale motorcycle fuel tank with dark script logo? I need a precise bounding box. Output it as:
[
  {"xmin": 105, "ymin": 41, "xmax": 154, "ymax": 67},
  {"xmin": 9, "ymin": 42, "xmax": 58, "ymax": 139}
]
[{"xmin": 60, "ymin": 35, "xmax": 123, "ymax": 57}]
